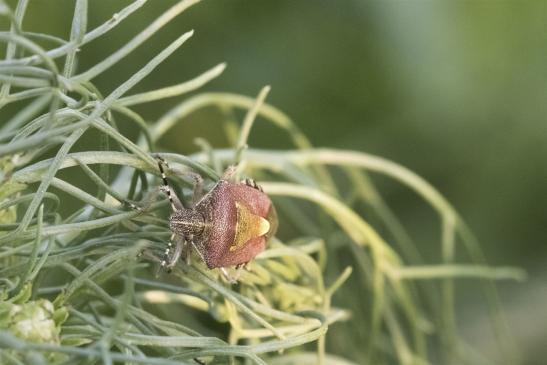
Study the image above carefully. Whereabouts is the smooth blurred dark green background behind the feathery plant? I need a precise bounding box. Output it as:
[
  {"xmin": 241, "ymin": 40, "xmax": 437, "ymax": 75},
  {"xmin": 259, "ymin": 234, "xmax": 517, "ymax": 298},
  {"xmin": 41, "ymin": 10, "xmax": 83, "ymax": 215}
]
[{"xmin": 9, "ymin": 0, "xmax": 547, "ymax": 364}]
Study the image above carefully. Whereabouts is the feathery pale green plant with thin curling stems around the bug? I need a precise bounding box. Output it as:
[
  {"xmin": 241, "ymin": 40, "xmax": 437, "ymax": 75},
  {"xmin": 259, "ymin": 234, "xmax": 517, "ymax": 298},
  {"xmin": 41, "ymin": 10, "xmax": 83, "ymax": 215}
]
[{"xmin": 0, "ymin": 0, "xmax": 523, "ymax": 365}]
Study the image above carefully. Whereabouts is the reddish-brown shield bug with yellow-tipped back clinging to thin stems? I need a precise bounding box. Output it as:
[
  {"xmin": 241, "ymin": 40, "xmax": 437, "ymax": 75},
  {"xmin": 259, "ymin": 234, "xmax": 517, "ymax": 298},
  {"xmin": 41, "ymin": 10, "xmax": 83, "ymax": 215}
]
[{"xmin": 154, "ymin": 157, "xmax": 277, "ymax": 281}]
